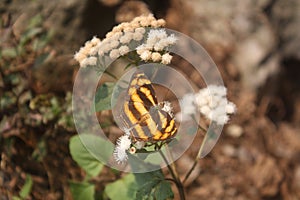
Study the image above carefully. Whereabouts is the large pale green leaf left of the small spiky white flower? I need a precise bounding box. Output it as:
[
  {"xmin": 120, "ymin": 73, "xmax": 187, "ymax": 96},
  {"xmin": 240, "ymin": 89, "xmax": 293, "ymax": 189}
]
[{"xmin": 69, "ymin": 134, "xmax": 114, "ymax": 177}]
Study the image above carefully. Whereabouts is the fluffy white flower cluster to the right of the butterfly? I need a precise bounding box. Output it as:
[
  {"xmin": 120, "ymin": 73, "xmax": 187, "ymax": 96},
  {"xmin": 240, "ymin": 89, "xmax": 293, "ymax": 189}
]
[{"xmin": 176, "ymin": 85, "xmax": 236, "ymax": 125}]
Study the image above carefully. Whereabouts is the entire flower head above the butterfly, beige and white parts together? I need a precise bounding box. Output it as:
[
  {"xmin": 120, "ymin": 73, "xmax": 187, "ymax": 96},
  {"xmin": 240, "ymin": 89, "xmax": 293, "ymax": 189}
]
[{"xmin": 74, "ymin": 14, "xmax": 172, "ymax": 67}]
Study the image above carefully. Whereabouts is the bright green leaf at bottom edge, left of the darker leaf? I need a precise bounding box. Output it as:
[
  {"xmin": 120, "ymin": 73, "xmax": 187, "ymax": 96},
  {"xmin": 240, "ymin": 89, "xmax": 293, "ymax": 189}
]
[{"xmin": 104, "ymin": 174, "xmax": 137, "ymax": 200}]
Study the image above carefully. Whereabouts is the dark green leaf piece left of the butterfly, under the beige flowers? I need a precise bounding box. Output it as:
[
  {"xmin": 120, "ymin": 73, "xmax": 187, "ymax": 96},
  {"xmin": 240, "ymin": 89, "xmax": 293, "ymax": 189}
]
[{"xmin": 95, "ymin": 83, "xmax": 115, "ymax": 112}]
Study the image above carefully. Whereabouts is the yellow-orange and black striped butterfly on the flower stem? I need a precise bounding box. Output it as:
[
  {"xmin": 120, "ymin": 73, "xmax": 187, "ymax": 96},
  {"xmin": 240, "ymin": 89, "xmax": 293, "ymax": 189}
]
[{"xmin": 121, "ymin": 70, "xmax": 177, "ymax": 142}]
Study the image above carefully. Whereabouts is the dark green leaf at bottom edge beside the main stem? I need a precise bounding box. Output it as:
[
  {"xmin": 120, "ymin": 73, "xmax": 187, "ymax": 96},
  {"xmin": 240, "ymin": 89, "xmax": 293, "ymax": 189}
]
[{"xmin": 134, "ymin": 170, "xmax": 174, "ymax": 200}]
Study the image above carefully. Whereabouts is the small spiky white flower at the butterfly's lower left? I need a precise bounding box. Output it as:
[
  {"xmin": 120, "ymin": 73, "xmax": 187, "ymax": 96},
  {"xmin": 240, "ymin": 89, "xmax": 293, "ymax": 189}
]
[{"xmin": 113, "ymin": 132, "xmax": 131, "ymax": 163}]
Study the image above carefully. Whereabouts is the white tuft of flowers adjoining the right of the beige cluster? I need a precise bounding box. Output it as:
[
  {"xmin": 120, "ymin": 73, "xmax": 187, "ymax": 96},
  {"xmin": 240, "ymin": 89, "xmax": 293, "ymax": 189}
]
[{"xmin": 136, "ymin": 29, "xmax": 177, "ymax": 64}]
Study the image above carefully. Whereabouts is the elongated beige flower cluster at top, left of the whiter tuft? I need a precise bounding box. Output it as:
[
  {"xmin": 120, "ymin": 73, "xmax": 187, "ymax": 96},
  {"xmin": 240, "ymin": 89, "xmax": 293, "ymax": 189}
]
[{"xmin": 74, "ymin": 14, "xmax": 165, "ymax": 67}]
